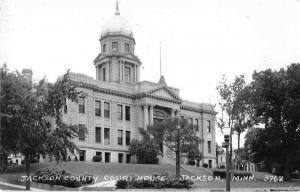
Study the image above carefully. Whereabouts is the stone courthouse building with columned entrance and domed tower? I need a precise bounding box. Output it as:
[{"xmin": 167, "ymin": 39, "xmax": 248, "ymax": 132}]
[{"xmin": 64, "ymin": 5, "xmax": 216, "ymax": 167}]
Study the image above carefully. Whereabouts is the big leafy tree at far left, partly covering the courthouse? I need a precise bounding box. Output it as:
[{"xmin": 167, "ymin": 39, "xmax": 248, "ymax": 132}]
[{"xmin": 0, "ymin": 65, "xmax": 86, "ymax": 190}]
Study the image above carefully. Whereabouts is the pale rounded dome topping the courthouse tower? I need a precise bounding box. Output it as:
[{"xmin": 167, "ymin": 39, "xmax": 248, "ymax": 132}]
[{"xmin": 101, "ymin": 14, "xmax": 132, "ymax": 37}]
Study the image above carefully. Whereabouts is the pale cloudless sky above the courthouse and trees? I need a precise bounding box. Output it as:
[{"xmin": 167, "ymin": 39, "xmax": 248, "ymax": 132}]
[{"xmin": 0, "ymin": 0, "xmax": 300, "ymax": 146}]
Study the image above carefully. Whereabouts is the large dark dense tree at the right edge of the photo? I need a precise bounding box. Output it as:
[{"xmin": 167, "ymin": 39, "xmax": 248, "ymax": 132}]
[{"xmin": 245, "ymin": 64, "xmax": 300, "ymax": 180}]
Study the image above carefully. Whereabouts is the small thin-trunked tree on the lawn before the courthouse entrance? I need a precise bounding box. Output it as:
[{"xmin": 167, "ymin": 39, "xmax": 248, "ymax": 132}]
[{"xmin": 147, "ymin": 118, "xmax": 203, "ymax": 176}]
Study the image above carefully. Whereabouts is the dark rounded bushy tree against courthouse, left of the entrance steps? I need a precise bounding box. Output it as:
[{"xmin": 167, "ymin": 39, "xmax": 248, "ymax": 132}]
[{"xmin": 129, "ymin": 129, "xmax": 159, "ymax": 164}]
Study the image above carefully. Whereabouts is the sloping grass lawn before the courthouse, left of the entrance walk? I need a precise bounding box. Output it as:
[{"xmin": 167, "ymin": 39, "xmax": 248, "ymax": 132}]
[{"xmin": 0, "ymin": 161, "xmax": 191, "ymax": 185}]
